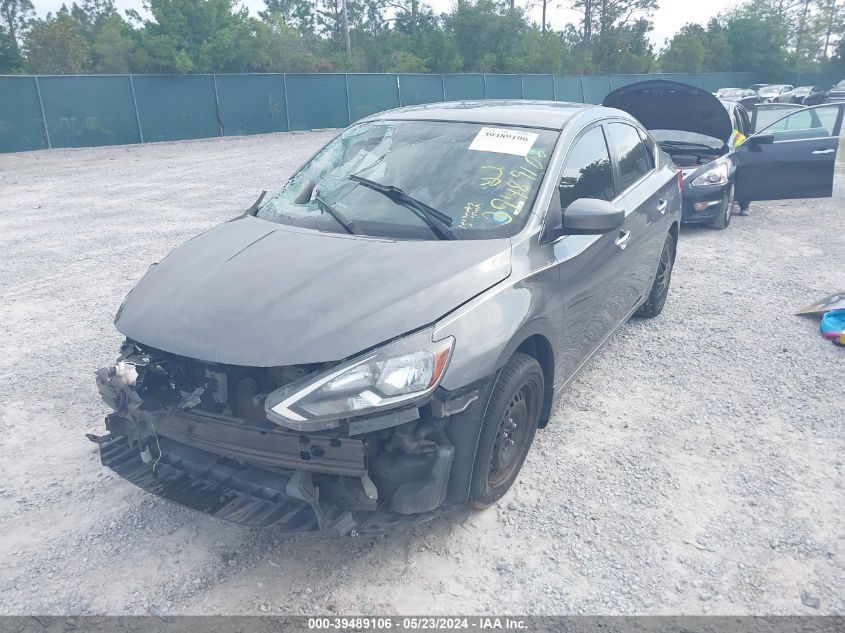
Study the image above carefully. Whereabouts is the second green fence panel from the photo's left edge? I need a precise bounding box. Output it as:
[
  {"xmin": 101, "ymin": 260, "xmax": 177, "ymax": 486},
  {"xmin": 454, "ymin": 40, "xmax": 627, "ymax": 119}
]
[{"xmin": 38, "ymin": 75, "xmax": 141, "ymax": 147}]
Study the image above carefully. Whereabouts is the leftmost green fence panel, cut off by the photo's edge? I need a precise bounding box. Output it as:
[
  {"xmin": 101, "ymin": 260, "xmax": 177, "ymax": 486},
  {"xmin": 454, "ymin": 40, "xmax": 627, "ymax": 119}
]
[{"xmin": 0, "ymin": 77, "xmax": 47, "ymax": 152}]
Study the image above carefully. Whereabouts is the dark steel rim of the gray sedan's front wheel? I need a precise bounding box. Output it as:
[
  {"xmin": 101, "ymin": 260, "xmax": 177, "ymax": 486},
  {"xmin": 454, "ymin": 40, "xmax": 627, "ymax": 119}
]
[{"xmin": 487, "ymin": 382, "xmax": 537, "ymax": 488}]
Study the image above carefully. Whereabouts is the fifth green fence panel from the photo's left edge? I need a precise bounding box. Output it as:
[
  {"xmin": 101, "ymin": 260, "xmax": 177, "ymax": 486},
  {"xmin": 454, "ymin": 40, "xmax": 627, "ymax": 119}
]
[{"xmin": 285, "ymin": 74, "xmax": 349, "ymax": 130}]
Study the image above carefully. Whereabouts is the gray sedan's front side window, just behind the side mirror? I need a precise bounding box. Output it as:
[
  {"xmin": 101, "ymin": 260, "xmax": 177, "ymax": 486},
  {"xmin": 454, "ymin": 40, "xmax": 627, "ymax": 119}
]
[{"xmin": 560, "ymin": 126, "xmax": 616, "ymax": 209}]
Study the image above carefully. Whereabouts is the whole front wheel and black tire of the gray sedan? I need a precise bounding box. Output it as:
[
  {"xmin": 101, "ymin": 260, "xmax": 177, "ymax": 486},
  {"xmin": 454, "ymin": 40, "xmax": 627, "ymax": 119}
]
[{"xmin": 467, "ymin": 352, "xmax": 544, "ymax": 510}]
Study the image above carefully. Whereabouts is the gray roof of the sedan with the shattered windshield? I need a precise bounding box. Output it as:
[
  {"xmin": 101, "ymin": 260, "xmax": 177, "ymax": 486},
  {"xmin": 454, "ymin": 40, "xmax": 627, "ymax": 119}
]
[{"xmin": 364, "ymin": 99, "xmax": 600, "ymax": 130}]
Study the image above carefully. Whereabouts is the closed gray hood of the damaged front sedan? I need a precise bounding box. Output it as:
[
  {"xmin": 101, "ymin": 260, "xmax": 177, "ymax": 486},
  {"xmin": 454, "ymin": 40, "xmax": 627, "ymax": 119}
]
[{"xmin": 115, "ymin": 216, "xmax": 510, "ymax": 367}]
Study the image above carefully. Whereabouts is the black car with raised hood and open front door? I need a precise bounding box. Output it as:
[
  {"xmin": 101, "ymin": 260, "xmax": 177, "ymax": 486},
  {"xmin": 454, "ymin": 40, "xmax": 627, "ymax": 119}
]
[{"xmin": 603, "ymin": 80, "xmax": 842, "ymax": 229}]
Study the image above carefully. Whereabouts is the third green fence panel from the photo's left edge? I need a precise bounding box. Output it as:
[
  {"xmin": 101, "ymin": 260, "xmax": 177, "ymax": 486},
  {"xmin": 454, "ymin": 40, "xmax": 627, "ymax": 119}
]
[{"xmin": 132, "ymin": 75, "xmax": 220, "ymax": 142}]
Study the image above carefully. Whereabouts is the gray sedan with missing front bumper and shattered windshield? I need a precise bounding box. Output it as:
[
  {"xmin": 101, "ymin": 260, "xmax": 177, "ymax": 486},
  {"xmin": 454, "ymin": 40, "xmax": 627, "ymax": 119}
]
[{"xmin": 91, "ymin": 101, "xmax": 681, "ymax": 533}]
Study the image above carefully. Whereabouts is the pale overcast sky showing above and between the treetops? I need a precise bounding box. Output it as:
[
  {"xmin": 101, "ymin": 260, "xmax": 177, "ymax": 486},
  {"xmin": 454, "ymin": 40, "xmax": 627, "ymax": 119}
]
[{"xmin": 33, "ymin": 0, "xmax": 740, "ymax": 46}]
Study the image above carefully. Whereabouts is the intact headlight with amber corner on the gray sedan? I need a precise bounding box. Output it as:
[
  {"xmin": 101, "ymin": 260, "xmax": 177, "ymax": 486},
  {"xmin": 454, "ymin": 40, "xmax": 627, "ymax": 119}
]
[{"xmin": 264, "ymin": 329, "xmax": 455, "ymax": 431}]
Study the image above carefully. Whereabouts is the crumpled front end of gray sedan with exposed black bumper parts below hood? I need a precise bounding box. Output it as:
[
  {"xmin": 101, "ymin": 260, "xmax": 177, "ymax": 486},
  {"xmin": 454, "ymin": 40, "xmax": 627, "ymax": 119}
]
[{"xmin": 89, "ymin": 341, "xmax": 472, "ymax": 534}]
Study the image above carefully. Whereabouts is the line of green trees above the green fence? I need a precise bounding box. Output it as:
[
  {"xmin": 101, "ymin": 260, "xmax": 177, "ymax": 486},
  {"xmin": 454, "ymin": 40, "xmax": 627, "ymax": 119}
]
[{"xmin": 0, "ymin": 0, "xmax": 845, "ymax": 78}]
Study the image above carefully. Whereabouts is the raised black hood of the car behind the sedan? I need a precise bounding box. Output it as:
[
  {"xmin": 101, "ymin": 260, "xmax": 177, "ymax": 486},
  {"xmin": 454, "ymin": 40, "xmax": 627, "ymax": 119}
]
[{"xmin": 602, "ymin": 79, "xmax": 733, "ymax": 142}]
